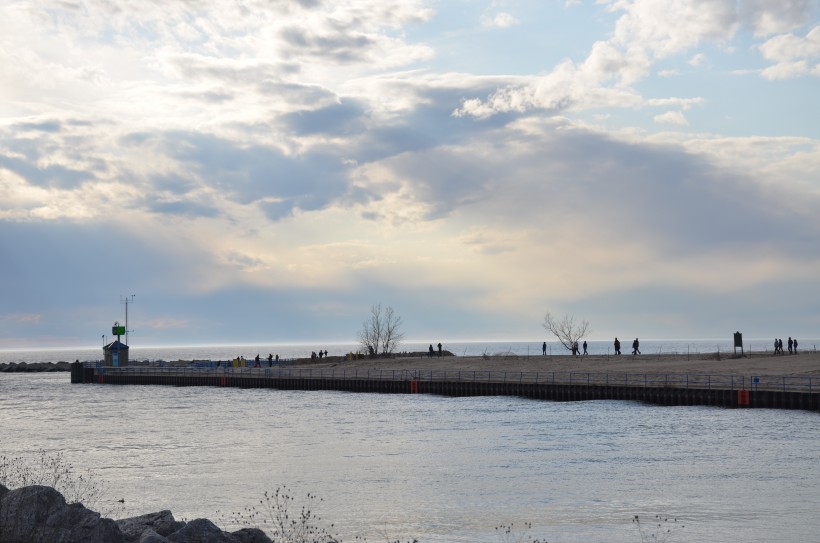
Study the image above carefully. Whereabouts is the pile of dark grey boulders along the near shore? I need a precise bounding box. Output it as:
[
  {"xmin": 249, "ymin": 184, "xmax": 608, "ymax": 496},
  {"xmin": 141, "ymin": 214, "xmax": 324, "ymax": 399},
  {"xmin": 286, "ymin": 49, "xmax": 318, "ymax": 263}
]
[{"xmin": 0, "ymin": 485, "xmax": 272, "ymax": 543}]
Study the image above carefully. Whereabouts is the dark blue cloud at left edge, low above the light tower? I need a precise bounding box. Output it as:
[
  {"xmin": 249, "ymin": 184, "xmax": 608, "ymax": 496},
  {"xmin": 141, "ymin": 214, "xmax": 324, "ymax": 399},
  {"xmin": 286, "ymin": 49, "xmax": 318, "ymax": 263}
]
[{"xmin": 0, "ymin": 220, "xmax": 224, "ymax": 345}]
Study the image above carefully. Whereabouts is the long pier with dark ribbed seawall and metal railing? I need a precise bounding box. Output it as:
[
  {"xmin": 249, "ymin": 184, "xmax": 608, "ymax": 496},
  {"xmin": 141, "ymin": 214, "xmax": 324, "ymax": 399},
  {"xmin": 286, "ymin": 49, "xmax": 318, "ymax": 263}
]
[{"xmin": 71, "ymin": 363, "xmax": 820, "ymax": 411}]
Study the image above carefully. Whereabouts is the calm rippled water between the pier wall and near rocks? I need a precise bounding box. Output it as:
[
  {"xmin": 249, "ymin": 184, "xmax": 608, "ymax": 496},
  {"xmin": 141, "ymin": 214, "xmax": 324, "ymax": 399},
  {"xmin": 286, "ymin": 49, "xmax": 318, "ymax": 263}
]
[{"xmin": 0, "ymin": 373, "xmax": 820, "ymax": 543}]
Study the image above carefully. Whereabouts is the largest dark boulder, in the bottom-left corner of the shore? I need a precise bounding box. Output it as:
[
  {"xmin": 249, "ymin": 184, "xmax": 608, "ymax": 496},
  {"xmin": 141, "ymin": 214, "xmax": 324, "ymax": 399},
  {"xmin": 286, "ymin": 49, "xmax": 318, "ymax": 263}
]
[{"xmin": 0, "ymin": 486, "xmax": 125, "ymax": 543}]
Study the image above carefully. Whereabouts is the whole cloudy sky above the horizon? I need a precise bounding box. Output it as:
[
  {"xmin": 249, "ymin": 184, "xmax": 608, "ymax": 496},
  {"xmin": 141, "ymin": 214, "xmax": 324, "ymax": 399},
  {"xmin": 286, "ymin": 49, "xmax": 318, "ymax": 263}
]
[{"xmin": 0, "ymin": 0, "xmax": 820, "ymax": 348}]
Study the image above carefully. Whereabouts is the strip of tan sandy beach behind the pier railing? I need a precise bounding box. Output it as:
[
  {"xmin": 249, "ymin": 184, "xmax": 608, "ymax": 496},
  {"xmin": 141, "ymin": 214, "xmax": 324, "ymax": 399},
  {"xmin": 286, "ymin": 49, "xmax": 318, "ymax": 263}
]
[{"xmin": 290, "ymin": 351, "xmax": 820, "ymax": 377}]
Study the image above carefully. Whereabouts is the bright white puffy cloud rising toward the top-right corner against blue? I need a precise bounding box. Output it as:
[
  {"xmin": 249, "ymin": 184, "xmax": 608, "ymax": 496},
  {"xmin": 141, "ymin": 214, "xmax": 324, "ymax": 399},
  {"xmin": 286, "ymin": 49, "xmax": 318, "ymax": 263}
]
[{"xmin": 455, "ymin": 0, "xmax": 815, "ymax": 118}]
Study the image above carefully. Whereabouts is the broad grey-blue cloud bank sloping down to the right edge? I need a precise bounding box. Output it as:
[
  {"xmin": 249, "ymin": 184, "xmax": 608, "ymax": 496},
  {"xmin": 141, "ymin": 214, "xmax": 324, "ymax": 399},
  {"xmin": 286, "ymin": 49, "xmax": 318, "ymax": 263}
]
[{"xmin": 386, "ymin": 123, "xmax": 820, "ymax": 256}]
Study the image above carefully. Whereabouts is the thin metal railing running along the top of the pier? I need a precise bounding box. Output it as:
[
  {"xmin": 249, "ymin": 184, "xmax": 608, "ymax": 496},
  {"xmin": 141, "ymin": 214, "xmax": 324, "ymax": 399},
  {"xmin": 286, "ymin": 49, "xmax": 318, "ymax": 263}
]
[{"xmin": 96, "ymin": 366, "xmax": 820, "ymax": 393}]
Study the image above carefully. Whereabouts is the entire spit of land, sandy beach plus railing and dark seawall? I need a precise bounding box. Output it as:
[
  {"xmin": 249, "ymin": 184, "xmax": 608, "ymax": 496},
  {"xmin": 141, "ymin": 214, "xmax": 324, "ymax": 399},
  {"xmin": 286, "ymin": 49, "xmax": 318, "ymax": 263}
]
[{"xmin": 72, "ymin": 351, "xmax": 820, "ymax": 411}]
